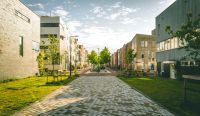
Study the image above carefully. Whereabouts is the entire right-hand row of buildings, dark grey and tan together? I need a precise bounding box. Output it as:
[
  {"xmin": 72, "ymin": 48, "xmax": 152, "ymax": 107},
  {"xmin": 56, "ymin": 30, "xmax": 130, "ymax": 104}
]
[{"xmin": 111, "ymin": 0, "xmax": 200, "ymax": 79}]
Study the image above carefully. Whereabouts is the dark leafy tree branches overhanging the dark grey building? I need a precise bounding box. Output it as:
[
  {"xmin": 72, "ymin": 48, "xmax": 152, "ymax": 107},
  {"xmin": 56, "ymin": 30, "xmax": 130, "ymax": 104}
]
[{"xmin": 165, "ymin": 14, "xmax": 200, "ymax": 66}]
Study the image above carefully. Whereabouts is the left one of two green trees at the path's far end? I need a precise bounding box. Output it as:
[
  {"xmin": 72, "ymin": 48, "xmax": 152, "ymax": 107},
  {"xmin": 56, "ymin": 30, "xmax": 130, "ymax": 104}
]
[{"xmin": 87, "ymin": 50, "xmax": 98, "ymax": 69}]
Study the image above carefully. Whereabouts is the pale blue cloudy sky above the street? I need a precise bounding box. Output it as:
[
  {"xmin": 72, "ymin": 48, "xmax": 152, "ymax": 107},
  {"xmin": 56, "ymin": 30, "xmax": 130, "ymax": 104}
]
[{"xmin": 21, "ymin": 0, "xmax": 175, "ymax": 53}]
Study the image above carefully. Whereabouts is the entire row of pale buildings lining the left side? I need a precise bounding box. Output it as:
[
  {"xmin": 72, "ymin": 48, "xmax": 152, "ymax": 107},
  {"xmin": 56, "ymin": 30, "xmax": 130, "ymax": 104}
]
[{"xmin": 0, "ymin": 0, "xmax": 87, "ymax": 80}]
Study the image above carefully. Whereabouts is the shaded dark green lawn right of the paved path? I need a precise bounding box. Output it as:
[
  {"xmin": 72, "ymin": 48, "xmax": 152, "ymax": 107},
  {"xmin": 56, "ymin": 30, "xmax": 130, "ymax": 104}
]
[{"xmin": 119, "ymin": 77, "xmax": 200, "ymax": 116}]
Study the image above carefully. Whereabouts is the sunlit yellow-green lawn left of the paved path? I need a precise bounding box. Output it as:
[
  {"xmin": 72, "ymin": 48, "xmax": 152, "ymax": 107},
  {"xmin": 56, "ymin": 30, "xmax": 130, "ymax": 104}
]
[{"xmin": 0, "ymin": 77, "xmax": 75, "ymax": 116}]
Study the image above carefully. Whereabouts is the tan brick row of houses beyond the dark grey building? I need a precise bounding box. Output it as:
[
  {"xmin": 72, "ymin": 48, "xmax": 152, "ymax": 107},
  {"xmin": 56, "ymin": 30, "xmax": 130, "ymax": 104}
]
[{"xmin": 111, "ymin": 33, "xmax": 156, "ymax": 72}]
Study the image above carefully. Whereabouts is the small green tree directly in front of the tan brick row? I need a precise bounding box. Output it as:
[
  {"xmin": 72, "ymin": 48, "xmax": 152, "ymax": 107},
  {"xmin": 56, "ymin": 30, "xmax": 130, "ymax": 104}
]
[{"xmin": 125, "ymin": 48, "xmax": 137, "ymax": 69}]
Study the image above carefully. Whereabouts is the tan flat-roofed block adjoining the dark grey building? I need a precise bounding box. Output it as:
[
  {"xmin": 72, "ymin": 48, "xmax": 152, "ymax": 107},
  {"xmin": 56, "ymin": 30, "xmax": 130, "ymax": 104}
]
[{"xmin": 130, "ymin": 34, "xmax": 156, "ymax": 72}]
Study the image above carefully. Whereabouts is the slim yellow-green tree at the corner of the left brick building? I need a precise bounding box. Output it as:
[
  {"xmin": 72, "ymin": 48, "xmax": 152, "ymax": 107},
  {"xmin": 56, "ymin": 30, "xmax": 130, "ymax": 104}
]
[{"xmin": 37, "ymin": 50, "xmax": 45, "ymax": 76}]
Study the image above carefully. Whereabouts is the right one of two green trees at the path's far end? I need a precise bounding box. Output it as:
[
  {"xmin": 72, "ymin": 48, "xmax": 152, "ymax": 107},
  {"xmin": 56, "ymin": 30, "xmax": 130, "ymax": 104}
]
[{"xmin": 100, "ymin": 47, "xmax": 111, "ymax": 64}]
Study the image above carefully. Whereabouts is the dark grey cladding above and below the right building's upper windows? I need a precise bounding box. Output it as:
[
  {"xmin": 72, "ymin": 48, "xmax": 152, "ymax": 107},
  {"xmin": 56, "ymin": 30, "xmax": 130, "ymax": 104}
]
[{"xmin": 156, "ymin": 0, "xmax": 200, "ymax": 62}]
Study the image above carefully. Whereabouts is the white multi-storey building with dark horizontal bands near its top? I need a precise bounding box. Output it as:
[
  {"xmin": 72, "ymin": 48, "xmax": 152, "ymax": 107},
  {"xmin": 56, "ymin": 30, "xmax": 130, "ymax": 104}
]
[{"xmin": 40, "ymin": 16, "xmax": 69, "ymax": 70}]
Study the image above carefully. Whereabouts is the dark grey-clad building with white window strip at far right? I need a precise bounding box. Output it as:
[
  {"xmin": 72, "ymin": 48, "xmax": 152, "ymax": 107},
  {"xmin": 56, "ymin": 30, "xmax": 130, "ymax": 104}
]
[{"xmin": 156, "ymin": 0, "xmax": 200, "ymax": 79}]
